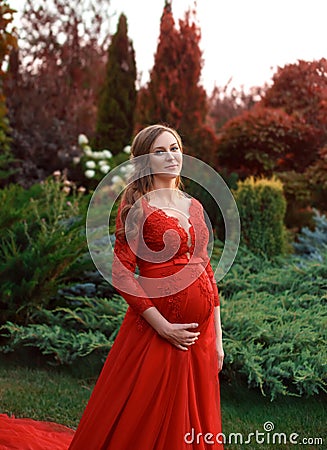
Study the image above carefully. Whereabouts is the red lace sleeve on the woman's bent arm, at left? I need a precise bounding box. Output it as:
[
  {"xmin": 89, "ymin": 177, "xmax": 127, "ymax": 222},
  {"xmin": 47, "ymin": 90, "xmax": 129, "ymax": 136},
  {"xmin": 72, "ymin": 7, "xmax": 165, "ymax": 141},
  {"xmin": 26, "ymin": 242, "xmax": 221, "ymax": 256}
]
[{"xmin": 112, "ymin": 205, "xmax": 154, "ymax": 314}]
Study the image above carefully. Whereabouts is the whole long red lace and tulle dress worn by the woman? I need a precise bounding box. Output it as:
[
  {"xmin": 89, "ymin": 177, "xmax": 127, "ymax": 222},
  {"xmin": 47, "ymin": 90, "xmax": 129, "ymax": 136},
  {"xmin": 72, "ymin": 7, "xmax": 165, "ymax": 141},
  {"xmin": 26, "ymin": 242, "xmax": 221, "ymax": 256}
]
[{"xmin": 0, "ymin": 198, "xmax": 223, "ymax": 450}]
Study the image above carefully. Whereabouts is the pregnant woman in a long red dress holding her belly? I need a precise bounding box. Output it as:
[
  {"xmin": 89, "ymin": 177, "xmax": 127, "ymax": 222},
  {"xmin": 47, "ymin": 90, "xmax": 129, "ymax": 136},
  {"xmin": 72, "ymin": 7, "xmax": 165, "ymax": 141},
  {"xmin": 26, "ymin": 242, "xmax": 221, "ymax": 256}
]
[{"xmin": 70, "ymin": 125, "xmax": 224, "ymax": 450}]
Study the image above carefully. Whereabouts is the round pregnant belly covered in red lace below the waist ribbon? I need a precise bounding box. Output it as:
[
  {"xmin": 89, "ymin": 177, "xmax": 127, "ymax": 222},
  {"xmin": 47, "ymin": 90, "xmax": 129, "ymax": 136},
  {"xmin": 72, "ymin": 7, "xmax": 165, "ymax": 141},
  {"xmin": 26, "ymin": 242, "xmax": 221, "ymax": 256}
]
[{"xmin": 142, "ymin": 265, "xmax": 214, "ymax": 326}]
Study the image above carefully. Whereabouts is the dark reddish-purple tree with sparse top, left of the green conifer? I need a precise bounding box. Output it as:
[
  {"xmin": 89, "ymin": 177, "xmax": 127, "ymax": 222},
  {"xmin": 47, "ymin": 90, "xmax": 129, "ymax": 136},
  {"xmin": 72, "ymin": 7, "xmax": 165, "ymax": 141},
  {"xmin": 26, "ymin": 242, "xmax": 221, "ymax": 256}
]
[{"xmin": 5, "ymin": 0, "xmax": 108, "ymax": 187}]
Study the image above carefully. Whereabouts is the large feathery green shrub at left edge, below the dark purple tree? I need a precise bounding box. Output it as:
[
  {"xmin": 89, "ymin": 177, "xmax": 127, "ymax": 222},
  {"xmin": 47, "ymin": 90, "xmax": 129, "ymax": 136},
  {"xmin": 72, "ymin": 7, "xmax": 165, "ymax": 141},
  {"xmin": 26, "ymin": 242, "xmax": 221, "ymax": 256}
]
[{"xmin": 0, "ymin": 174, "xmax": 90, "ymax": 323}]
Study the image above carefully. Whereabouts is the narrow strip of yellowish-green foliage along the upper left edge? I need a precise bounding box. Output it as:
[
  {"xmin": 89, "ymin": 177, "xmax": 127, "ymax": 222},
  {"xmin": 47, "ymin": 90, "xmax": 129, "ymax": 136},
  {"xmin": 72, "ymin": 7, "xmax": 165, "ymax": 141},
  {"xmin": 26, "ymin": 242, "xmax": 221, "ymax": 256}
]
[{"xmin": 0, "ymin": 2, "xmax": 17, "ymax": 184}]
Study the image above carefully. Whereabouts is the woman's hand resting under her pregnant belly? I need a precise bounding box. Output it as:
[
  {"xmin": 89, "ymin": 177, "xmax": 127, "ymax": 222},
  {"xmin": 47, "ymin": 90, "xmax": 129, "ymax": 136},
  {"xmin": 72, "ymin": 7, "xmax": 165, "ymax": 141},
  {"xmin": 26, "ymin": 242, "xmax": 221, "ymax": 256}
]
[{"xmin": 157, "ymin": 322, "xmax": 200, "ymax": 350}]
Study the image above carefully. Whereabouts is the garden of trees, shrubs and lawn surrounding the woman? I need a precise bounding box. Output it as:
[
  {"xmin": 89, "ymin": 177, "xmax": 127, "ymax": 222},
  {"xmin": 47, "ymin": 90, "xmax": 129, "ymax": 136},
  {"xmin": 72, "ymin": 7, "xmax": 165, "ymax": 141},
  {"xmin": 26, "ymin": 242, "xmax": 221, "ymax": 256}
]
[{"xmin": 0, "ymin": 0, "xmax": 327, "ymax": 450}]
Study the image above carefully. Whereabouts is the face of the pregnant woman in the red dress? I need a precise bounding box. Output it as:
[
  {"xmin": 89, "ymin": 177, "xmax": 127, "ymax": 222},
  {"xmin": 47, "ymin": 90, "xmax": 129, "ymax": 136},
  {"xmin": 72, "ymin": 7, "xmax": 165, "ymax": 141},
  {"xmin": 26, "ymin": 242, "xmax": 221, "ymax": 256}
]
[{"xmin": 150, "ymin": 131, "xmax": 183, "ymax": 178}]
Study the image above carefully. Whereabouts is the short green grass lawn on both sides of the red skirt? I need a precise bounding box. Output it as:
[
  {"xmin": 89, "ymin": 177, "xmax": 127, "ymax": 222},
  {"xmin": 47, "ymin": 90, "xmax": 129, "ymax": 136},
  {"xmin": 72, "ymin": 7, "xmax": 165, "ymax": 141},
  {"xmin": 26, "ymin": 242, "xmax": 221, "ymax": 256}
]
[{"xmin": 0, "ymin": 356, "xmax": 327, "ymax": 450}]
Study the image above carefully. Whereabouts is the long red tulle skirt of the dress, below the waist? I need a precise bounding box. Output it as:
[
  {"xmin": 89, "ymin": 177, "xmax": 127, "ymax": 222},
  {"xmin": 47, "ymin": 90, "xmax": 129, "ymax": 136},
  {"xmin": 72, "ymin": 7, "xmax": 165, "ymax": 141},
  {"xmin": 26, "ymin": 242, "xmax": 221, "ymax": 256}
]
[{"xmin": 70, "ymin": 266, "xmax": 223, "ymax": 450}]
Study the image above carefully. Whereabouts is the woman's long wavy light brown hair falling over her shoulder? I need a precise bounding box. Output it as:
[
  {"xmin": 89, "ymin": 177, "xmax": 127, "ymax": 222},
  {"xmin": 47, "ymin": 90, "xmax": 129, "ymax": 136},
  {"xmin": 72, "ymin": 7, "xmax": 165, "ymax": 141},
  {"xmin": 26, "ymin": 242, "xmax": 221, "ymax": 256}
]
[{"xmin": 116, "ymin": 124, "xmax": 183, "ymax": 238}]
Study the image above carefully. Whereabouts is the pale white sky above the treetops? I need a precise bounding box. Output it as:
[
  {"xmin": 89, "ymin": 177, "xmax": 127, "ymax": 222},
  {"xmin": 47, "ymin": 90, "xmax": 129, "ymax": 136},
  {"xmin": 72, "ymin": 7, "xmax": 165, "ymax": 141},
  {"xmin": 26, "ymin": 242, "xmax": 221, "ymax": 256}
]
[{"xmin": 9, "ymin": 0, "xmax": 327, "ymax": 94}]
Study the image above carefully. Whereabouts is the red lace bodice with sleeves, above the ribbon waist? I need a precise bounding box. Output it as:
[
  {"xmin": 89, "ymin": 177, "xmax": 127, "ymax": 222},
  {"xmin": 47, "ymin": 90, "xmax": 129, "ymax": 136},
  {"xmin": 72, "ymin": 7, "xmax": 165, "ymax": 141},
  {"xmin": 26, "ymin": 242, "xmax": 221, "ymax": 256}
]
[{"xmin": 112, "ymin": 198, "xmax": 220, "ymax": 314}]
